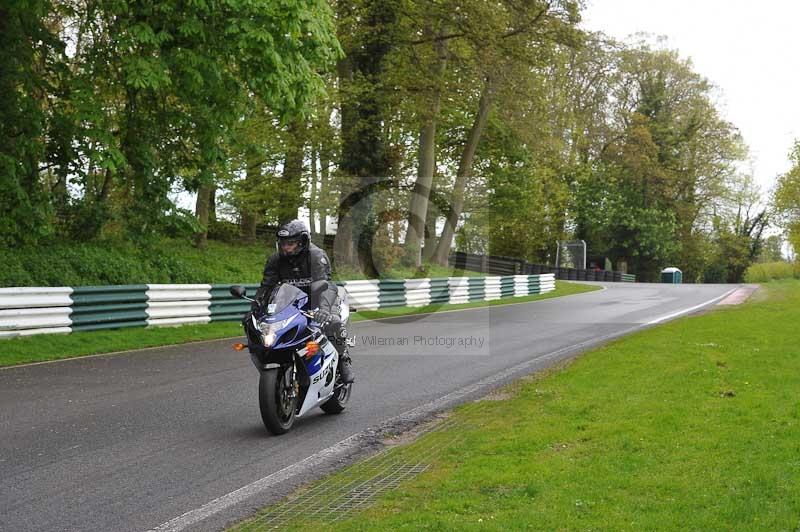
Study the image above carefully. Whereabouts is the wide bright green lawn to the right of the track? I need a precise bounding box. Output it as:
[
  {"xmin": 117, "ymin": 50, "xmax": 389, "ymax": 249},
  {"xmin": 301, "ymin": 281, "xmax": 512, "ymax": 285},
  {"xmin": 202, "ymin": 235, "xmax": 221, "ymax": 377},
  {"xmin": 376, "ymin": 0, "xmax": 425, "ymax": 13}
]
[{"xmin": 234, "ymin": 280, "xmax": 800, "ymax": 531}]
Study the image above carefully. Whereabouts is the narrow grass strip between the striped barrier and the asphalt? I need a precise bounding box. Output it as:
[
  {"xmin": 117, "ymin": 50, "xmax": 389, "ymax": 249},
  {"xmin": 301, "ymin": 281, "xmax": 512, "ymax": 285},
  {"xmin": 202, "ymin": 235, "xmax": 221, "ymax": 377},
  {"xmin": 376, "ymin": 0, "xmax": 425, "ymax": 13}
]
[{"xmin": 0, "ymin": 281, "xmax": 596, "ymax": 366}]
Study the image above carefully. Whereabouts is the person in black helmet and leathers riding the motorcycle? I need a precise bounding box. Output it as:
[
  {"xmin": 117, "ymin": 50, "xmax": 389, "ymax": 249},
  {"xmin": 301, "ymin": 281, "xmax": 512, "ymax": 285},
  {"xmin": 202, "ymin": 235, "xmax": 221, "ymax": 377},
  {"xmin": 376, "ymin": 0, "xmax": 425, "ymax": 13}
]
[{"xmin": 256, "ymin": 220, "xmax": 353, "ymax": 383}]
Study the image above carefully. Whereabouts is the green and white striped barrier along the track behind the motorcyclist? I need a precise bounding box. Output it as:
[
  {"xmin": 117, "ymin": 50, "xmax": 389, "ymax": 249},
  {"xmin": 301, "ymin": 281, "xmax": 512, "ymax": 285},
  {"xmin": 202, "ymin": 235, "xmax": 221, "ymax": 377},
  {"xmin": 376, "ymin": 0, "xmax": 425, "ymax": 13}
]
[{"xmin": 0, "ymin": 273, "xmax": 555, "ymax": 338}]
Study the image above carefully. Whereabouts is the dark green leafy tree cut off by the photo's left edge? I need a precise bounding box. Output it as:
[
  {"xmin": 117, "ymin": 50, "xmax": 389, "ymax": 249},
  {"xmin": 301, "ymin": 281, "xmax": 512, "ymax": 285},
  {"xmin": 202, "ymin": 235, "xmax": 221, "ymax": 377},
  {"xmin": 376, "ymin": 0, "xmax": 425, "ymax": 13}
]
[{"xmin": 0, "ymin": 0, "xmax": 69, "ymax": 246}]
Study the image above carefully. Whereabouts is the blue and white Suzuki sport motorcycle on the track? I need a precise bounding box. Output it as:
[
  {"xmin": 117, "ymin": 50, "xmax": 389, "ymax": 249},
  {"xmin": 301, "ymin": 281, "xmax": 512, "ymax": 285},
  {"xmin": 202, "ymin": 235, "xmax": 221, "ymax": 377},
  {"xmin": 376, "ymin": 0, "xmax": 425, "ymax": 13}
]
[{"xmin": 230, "ymin": 281, "xmax": 352, "ymax": 434}]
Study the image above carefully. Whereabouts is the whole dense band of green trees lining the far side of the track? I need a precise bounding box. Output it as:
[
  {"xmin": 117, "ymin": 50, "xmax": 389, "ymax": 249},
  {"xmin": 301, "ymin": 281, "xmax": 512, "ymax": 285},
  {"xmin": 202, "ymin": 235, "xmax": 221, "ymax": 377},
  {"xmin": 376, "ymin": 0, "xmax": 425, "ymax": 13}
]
[{"xmin": 0, "ymin": 0, "xmax": 788, "ymax": 284}]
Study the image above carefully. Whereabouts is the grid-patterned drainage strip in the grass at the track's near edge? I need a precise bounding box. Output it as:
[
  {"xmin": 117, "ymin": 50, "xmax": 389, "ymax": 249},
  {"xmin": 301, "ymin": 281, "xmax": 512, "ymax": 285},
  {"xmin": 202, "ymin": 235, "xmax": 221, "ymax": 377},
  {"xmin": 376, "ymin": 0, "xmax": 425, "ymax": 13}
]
[{"xmin": 233, "ymin": 419, "xmax": 460, "ymax": 532}]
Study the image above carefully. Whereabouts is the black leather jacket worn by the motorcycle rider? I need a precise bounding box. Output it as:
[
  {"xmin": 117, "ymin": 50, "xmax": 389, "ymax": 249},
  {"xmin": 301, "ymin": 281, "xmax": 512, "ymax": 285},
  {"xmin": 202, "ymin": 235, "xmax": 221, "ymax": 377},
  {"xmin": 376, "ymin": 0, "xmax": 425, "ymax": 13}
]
[{"xmin": 256, "ymin": 243, "xmax": 338, "ymax": 313}]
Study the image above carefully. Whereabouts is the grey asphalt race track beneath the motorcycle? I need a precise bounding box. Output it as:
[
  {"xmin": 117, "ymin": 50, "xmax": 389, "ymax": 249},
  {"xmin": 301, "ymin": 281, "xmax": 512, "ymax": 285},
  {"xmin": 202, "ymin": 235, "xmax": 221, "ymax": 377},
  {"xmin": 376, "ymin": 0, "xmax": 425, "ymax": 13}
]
[{"xmin": 0, "ymin": 283, "xmax": 734, "ymax": 532}]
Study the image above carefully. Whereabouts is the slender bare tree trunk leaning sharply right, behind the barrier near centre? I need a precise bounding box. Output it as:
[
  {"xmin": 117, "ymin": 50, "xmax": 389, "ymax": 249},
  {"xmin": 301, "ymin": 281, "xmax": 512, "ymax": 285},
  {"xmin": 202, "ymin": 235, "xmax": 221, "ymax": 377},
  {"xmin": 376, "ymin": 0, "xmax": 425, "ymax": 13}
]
[{"xmin": 433, "ymin": 78, "xmax": 494, "ymax": 266}]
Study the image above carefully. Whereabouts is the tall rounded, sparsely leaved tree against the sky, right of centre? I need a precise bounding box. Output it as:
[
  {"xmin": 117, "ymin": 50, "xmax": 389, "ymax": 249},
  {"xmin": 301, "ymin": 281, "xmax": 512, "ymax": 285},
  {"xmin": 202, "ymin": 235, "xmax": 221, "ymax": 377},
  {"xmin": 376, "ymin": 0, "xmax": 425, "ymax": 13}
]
[{"xmin": 575, "ymin": 39, "xmax": 746, "ymax": 280}]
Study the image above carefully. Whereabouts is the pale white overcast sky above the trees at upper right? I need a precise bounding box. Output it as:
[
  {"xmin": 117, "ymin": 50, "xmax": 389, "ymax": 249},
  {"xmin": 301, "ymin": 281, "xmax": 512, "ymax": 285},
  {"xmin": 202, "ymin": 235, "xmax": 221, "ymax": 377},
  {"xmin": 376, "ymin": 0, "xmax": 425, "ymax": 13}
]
[{"xmin": 582, "ymin": 0, "xmax": 800, "ymax": 192}]
